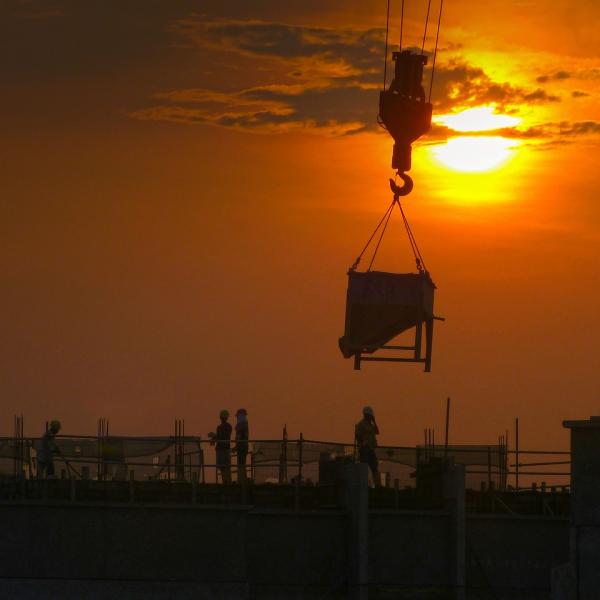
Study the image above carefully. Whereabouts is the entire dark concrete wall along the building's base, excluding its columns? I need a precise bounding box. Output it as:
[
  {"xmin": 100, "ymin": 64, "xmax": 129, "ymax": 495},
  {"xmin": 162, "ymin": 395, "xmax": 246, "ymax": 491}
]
[{"xmin": 0, "ymin": 503, "xmax": 568, "ymax": 600}]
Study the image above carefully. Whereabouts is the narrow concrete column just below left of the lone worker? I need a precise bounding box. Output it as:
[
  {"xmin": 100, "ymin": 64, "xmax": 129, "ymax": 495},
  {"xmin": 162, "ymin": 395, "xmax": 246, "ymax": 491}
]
[{"xmin": 343, "ymin": 463, "xmax": 369, "ymax": 600}]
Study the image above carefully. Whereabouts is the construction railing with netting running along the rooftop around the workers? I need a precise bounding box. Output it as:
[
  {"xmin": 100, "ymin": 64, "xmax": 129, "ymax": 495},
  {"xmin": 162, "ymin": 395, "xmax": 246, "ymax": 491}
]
[{"xmin": 0, "ymin": 432, "xmax": 570, "ymax": 490}]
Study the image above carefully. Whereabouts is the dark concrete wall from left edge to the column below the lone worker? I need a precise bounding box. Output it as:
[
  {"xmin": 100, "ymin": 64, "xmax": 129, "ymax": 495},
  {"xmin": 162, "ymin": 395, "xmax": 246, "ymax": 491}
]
[{"xmin": 0, "ymin": 504, "xmax": 346, "ymax": 599}]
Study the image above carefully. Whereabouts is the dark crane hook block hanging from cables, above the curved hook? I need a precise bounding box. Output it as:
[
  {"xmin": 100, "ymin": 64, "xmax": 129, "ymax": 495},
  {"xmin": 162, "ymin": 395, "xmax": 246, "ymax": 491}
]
[{"xmin": 379, "ymin": 50, "xmax": 432, "ymax": 172}]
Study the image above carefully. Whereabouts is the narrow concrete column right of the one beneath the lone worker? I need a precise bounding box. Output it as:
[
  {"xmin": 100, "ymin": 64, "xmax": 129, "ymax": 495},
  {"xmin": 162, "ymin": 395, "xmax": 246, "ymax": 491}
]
[{"xmin": 443, "ymin": 463, "xmax": 467, "ymax": 600}]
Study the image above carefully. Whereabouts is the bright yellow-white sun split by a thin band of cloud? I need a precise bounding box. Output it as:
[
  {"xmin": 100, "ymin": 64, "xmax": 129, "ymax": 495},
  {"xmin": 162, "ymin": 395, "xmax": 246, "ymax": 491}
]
[{"xmin": 431, "ymin": 106, "xmax": 521, "ymax": 172}]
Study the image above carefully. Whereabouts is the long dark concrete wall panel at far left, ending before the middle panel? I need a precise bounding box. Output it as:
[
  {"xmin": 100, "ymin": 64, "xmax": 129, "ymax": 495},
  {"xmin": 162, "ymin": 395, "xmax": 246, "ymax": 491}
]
[{"xmin": 0, "ymin": 504, "xmax": 246, "ymax": 582}]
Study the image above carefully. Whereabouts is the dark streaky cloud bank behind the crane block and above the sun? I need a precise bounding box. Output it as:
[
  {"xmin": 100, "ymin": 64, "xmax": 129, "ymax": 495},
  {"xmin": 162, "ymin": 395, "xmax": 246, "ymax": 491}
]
[{"xmin": 130, "ymin": 17, "xmax": 572, "ymax": 142}]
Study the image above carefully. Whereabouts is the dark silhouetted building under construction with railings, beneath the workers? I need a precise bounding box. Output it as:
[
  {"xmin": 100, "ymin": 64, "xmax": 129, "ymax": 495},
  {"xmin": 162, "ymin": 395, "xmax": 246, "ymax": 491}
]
[{"xmin": 0, "ymin": 419, "xmax": 600, "ymax": 600}]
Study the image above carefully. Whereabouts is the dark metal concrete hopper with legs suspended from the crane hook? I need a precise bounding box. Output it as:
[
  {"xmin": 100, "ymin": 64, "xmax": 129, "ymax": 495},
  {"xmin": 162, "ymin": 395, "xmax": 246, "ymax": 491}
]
[{"xmin": 339, "ymin": 270, "xmax": 435, "ymax": 371}]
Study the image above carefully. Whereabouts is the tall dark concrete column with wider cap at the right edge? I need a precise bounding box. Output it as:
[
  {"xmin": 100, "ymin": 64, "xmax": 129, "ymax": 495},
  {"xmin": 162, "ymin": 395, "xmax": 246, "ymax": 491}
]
[{"xmin": 552, "ymin": 417, "xmax": 600, "ymax": 600}]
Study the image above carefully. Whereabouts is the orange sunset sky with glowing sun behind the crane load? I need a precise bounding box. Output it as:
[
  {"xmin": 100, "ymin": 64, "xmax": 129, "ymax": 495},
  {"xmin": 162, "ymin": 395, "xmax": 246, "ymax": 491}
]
[{"xmin": 0, "ymin": 0, "xmax": 600, "ymax": 449}]
